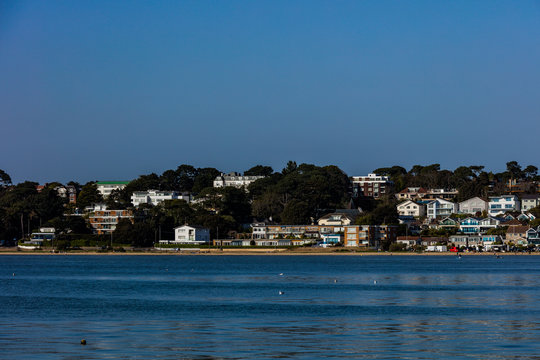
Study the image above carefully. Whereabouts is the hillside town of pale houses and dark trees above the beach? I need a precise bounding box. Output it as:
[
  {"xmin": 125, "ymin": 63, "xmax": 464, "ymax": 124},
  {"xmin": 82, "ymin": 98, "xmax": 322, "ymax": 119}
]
[{"xmin": 0, "ymin": 161, "xmax": 540, "ymax": 252}]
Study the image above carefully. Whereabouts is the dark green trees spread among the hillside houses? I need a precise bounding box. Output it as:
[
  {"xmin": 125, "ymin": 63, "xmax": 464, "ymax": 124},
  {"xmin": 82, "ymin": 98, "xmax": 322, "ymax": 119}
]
[{"xmin": 0, "ymin": 161, "xmax": 540, "ymax": 246}]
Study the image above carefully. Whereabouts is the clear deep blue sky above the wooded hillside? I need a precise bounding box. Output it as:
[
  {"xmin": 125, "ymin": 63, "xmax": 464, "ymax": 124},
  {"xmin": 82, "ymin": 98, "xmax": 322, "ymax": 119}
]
[{"xmin": 0, "ymin": 0, "xmax": 540, "ymax": 183}]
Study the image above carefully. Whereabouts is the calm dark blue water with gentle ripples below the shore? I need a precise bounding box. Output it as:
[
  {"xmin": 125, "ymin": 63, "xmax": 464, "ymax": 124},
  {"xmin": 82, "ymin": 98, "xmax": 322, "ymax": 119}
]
[{"xmin": 0, "ymin": 256, "xmax": 540, "ymax": 359}]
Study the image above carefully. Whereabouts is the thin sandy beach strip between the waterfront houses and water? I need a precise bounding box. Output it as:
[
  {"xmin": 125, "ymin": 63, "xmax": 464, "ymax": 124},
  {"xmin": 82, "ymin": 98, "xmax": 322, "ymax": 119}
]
[{"xmin": 0, "ymin": 249, "xmax": 540, "ymax": 256}]
